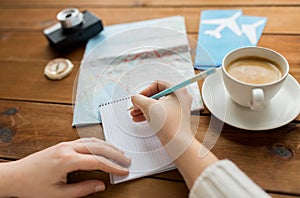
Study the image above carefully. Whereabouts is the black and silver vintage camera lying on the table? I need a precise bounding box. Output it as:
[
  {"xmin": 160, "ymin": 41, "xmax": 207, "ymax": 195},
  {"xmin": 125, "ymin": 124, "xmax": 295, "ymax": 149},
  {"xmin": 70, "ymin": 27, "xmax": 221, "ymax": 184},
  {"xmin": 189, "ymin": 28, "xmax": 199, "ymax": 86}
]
[{"xmin": 44, "ymin": 8, "xmax": 103, "ymax": 52}]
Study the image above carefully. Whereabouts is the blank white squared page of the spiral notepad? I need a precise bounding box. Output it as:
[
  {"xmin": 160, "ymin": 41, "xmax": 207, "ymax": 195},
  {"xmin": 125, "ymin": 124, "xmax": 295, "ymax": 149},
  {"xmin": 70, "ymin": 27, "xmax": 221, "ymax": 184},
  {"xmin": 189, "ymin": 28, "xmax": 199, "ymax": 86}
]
[{"xmin": 99, "ymin": 98, "xmax": 175, "ymax": 184}]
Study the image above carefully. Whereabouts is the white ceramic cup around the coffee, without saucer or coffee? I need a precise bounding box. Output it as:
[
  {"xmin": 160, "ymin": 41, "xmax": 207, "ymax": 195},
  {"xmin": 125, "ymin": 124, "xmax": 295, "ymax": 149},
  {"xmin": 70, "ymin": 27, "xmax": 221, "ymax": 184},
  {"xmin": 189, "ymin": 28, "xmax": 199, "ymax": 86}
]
[{"xmin": 222, "ymin": 47, "xmax": 289, "ymax": 111}]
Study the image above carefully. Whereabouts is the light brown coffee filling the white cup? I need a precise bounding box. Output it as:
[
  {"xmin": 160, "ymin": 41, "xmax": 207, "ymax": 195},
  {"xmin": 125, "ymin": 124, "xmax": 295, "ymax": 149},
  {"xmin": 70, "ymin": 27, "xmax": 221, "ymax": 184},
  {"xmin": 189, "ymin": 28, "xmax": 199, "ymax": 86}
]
[{"xmin": 226, "ymin": 56, "xmax": 283, "ymax": 84}]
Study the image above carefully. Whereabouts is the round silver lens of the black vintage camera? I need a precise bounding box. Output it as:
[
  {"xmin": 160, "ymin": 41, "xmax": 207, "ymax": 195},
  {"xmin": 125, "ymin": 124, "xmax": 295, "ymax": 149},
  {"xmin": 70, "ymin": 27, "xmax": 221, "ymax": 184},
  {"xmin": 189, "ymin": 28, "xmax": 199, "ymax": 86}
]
[{"xmin": 57, "ymin": 8, "xmax": 83, "ymax": 29}]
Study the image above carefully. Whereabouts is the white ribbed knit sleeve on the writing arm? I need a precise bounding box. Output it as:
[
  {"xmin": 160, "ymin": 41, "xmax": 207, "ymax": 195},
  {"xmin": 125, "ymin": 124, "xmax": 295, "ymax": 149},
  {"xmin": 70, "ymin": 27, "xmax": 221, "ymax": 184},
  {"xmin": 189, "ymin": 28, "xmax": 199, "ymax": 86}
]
[{"xmin": 189, "ymin": 160, "xmax": 270, "ymax": 198}]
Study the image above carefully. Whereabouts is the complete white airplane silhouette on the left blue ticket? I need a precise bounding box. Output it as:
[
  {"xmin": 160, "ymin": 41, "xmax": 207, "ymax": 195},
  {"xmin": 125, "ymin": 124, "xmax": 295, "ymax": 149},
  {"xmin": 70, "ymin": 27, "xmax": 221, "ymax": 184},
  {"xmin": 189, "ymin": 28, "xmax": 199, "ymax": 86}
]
[{"xmin": 201, "ymin": 12, "xmax": 242, "ymax": 39}]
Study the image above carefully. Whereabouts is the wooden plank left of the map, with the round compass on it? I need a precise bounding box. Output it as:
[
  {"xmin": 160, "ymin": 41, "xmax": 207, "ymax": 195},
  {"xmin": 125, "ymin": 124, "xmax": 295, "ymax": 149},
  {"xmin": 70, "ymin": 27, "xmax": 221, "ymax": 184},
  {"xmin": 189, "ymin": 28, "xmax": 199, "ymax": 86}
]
[{"xmin": 0, "ymin": 61, "xmax": 79, "ymax": 104}]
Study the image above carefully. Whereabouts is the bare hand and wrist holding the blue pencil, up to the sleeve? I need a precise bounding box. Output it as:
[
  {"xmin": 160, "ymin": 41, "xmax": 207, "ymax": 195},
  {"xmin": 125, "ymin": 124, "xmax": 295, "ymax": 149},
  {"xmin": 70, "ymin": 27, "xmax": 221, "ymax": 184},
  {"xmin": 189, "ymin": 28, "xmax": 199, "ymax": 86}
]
[{"xmin": 130, "ymin": 82, "xmax": 218, "ymax": 188}]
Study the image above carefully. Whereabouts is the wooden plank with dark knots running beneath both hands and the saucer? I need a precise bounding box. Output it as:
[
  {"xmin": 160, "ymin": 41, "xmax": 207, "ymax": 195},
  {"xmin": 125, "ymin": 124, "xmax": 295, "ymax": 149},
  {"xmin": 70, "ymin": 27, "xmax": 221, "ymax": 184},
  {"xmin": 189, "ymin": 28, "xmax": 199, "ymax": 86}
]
[{"xmin": 0, "ymin": 100, "xmax": 300, "ymax": 195}]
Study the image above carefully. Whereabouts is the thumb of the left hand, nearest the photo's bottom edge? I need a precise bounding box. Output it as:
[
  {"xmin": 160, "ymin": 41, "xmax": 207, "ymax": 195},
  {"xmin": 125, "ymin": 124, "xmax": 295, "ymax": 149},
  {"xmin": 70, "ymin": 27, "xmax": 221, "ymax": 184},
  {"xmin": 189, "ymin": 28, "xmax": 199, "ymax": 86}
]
[{"xmin": 59, "ymin": 180, "xmax": 105, "ymax": 197}]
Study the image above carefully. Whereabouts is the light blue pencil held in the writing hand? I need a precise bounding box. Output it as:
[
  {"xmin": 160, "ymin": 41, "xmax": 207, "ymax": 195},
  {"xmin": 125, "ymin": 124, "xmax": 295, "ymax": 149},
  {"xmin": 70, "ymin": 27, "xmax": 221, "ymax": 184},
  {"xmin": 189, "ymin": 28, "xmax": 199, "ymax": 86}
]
[{"xmin": 128, "ymin": 68, "xmax": 216, "ymax": 111}]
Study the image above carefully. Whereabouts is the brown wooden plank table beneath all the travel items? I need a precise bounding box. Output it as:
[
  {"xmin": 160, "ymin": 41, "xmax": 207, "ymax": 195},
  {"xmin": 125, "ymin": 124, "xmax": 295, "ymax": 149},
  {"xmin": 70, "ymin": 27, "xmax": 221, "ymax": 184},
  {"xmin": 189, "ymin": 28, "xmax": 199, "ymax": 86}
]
[{"xmin": 0, "ymin": 0, "xmax": 300, "ymax": 197}]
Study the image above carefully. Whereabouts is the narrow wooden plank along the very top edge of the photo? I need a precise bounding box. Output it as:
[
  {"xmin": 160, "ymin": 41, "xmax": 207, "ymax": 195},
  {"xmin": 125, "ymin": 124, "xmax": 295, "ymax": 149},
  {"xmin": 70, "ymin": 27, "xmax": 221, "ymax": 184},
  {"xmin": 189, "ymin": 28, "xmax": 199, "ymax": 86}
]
[{"xmin": 0, "ymin": 0, "xmax": 300, "ymax": 7}]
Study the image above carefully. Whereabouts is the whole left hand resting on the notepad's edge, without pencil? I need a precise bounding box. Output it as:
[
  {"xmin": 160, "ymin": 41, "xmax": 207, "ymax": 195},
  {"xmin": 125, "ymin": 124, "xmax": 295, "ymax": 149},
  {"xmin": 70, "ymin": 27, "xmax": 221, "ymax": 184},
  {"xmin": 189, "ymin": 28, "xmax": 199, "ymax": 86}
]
[{"xmin": 0, "ymin": 138, "xmax": 130, "ymax": 198}]
